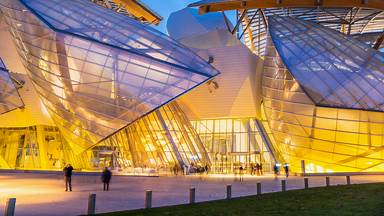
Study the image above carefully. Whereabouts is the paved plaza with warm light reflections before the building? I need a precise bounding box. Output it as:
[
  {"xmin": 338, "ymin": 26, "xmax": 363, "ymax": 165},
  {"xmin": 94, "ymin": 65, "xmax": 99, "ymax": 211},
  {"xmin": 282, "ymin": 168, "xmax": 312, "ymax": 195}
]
[{"xmin": 0, "ymin": 173, "xmax": 384, "ymax": 216}]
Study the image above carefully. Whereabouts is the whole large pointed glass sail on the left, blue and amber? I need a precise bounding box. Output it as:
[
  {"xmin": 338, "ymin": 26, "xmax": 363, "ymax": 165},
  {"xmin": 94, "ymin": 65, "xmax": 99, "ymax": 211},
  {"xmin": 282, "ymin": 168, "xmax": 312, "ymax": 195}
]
[{"xmin": 0, "ymin": 0, "xmax": 219, "ymax": 152}]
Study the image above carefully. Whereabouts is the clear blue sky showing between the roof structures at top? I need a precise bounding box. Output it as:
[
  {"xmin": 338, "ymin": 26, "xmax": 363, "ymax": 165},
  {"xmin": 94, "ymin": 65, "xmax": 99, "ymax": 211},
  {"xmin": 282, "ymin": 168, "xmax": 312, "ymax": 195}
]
[{"xmin": 141, "ymin": 0, "xmax": 236, "ymax": 33}]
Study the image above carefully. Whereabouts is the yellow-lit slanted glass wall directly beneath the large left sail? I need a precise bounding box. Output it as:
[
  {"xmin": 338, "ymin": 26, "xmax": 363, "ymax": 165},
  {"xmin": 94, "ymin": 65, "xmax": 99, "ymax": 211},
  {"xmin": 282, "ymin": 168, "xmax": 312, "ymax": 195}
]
[{"xmin": 92, "ymin": 102, "xmax": 211, "ymax": 170}]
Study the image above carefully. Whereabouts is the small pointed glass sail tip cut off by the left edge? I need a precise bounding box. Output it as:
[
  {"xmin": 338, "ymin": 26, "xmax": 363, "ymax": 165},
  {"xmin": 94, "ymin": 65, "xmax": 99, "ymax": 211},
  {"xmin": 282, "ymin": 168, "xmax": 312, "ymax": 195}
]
[{"xmin": 0, "ymin": 59, "xmax": 24, "ymax": 114}]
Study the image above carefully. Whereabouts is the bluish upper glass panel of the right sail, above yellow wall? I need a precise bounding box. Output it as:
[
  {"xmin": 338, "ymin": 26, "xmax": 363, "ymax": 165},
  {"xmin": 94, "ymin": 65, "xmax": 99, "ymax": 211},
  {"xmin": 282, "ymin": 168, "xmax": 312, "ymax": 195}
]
[{"xmin": 269, "ymin": 16, "xmax": 384, "ymax": 111}]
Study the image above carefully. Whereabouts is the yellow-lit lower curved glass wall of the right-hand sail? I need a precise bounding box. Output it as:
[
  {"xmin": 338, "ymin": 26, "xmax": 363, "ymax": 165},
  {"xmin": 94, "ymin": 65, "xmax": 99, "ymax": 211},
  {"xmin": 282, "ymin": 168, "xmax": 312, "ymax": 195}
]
[{"xmin": 263, "ymin": 18, "xmax": 384, "ymax": 172}]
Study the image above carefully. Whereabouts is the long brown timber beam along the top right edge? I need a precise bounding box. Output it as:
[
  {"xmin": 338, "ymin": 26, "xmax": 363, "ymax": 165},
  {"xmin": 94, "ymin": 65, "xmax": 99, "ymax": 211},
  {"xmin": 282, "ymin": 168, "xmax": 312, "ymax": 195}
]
[{"xmin": 189, "ymin": 0, "xmax": 384, "ymax": 14}]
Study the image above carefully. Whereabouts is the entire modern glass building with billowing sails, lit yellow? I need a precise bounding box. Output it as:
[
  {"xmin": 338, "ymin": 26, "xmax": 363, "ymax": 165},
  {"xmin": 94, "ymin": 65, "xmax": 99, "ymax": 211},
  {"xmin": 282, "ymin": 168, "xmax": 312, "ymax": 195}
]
[{"xmin": 0, "ymin": 0, "xmax": 384, "ymax": 173}]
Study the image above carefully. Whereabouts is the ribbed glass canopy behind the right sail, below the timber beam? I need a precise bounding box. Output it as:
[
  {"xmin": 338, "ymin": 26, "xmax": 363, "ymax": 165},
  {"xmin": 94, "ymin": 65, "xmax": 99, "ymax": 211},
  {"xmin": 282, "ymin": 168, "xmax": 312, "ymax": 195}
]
[{"xmin": 238, "ymin": 7, "xmax": 384, "ymax": 57}]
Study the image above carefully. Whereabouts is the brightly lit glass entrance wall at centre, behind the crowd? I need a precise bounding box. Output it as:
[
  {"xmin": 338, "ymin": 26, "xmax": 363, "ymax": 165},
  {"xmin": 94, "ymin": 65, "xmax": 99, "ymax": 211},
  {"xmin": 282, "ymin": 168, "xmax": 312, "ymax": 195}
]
[{"xmin": 192, "ymin": 118, "xmax": 274, "ymax": 173}]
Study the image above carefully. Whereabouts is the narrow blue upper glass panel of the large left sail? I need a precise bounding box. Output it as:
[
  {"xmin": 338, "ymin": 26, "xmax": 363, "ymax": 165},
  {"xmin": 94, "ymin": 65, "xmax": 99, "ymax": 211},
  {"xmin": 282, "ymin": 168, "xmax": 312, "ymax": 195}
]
[{"xmin": 21, "ymin": 0, "xmax": 218, "ymax": 76}]
